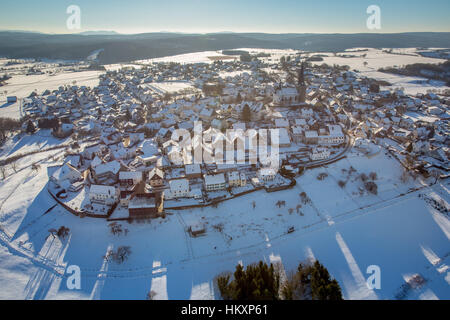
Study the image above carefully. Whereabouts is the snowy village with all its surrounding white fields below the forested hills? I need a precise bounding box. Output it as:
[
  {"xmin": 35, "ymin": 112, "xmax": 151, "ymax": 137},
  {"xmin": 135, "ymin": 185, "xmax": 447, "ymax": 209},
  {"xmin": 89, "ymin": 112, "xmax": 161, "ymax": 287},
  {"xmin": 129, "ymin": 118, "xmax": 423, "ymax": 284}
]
[{"xmin": 0, "ymin": 1, "xmax": 450, "ymax": 300}]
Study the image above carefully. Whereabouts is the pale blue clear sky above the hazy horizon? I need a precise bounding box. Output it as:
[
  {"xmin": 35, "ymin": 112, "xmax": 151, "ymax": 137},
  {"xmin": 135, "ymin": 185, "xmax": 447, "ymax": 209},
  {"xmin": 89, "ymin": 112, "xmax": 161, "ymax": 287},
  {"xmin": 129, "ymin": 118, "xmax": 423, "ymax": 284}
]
[{"xmin": 0, "ymin": 0, "xmax": 450, "ymax": 33}]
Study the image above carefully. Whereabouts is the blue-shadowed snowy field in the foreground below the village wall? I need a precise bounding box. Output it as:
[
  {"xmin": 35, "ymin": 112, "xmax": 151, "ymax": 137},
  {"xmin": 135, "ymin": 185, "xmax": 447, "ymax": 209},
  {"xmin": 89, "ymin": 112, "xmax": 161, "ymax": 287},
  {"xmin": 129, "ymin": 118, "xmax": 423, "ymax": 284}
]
[{"xmin": 0, "ymin": 139, "xmax": 450, "ymax": 299}]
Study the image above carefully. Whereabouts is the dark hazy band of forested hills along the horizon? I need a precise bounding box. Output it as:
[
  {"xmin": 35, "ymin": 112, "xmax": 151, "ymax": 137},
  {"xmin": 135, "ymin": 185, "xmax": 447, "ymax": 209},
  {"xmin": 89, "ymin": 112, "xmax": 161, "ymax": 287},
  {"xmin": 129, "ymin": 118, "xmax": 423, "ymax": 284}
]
[{"xmin": 0, "ymin": 31, "xmax": 450, "ymax": 64}]
